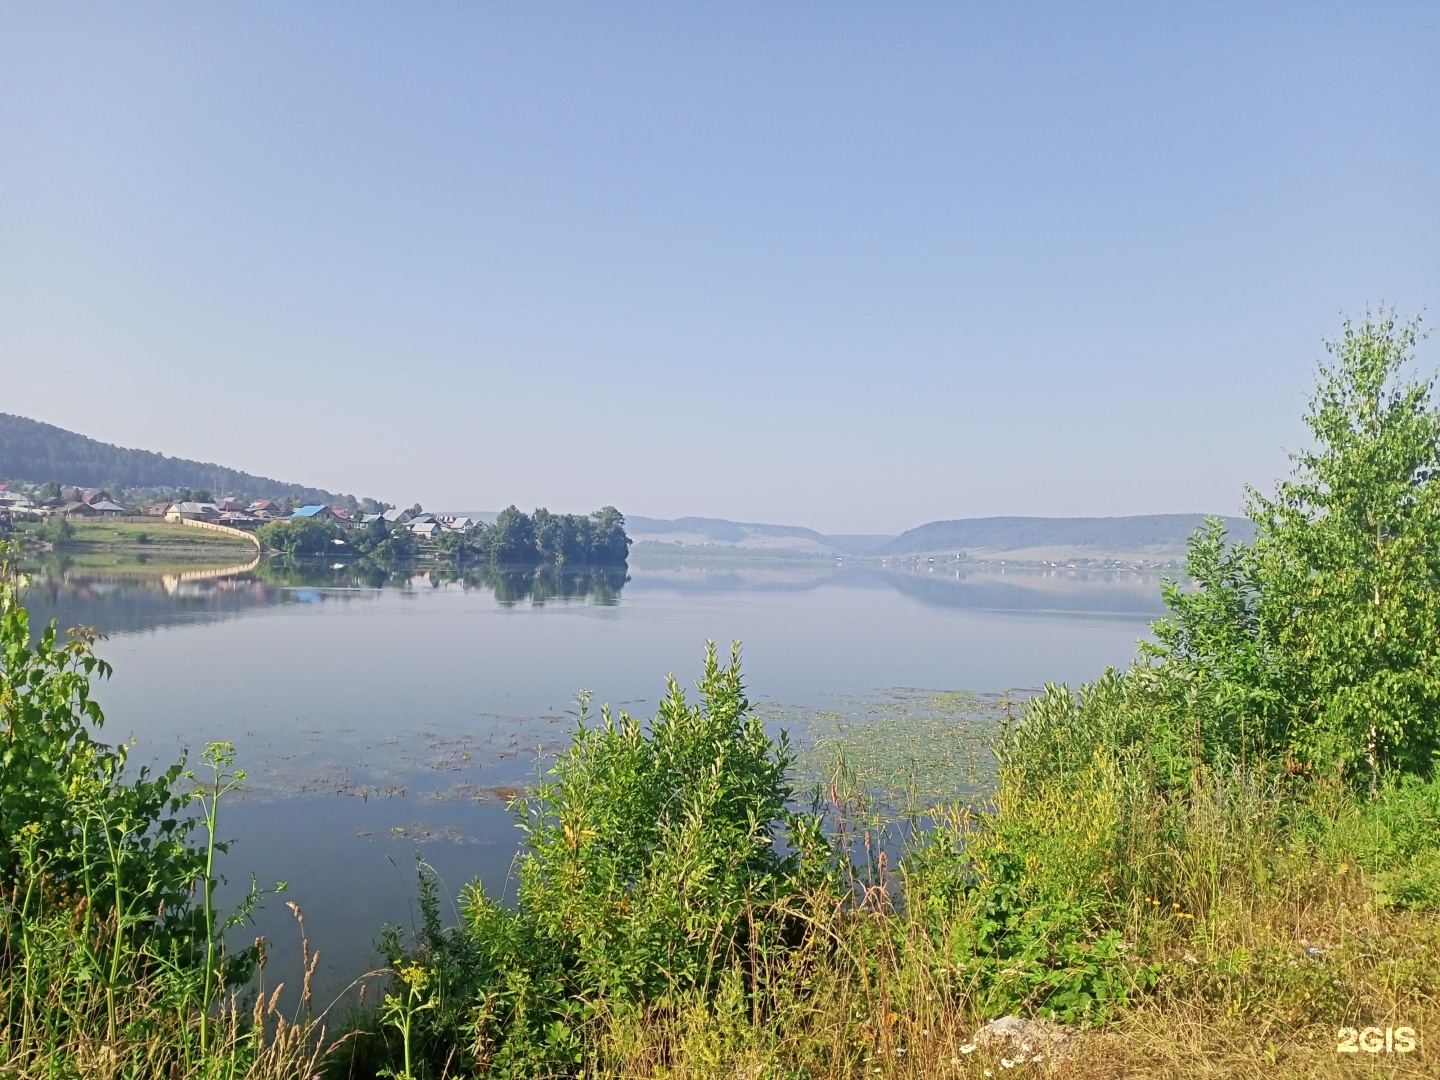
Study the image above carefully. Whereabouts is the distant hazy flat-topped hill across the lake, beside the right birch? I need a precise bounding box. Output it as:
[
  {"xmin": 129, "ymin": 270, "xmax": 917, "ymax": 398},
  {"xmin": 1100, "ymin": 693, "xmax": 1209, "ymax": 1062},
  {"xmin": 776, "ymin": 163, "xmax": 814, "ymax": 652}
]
[{"xmin": 880, "ymin": 514, "xmax": 1253, "ymax": 554}]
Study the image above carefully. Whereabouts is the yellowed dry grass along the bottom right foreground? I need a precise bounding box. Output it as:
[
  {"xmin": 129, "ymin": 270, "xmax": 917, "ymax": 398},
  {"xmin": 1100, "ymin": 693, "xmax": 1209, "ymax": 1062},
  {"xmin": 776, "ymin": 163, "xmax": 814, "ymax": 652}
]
[{"xmin": 588, "ymin": 906, "xmax": 1440, "ymax": 1080}]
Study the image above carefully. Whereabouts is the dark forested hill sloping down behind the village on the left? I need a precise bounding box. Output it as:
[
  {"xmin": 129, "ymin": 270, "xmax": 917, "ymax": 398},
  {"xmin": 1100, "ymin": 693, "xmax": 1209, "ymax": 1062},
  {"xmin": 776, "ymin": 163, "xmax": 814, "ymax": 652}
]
[{"xmin": 0, "ymin": 413, "xmax": 338, "ymax": 503}]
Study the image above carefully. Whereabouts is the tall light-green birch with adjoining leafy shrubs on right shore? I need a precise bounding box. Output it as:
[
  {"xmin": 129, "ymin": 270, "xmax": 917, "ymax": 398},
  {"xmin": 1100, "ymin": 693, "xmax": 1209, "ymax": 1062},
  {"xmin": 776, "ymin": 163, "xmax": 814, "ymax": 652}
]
[{"xmin": 1151, "ymin": 312, "xmax": 1440, "ymax": 788}]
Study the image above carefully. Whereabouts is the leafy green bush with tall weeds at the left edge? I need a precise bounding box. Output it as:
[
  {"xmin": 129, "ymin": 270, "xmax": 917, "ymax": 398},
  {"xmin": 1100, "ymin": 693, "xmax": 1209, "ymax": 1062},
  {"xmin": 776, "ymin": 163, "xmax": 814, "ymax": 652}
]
[{"xmin": 0, "ymin": 546, "xmax": 279, "ymax": 1074}]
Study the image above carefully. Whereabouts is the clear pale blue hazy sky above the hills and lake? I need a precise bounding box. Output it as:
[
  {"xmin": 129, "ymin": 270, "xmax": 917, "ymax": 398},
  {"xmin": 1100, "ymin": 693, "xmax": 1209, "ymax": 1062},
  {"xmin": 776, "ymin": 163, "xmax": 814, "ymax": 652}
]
[{"xmin": 0, "ymin": 0, "xmax": 1440, "ymax": 531}]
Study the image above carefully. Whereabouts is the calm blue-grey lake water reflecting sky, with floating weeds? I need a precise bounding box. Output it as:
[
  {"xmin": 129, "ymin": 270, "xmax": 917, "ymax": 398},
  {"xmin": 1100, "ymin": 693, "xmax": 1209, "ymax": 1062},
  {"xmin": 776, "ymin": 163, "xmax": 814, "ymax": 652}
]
[{"xmin": 19, "ymin": 557, "xmax": 1162, "ymax": 999}]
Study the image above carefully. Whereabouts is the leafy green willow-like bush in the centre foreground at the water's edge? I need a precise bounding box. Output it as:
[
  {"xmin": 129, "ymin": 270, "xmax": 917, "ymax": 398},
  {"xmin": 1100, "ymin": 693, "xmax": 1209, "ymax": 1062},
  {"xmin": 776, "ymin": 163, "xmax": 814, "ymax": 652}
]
[{"xmin": 387, "ymin": 645, "xmax": 818, "ymax": 1076}]
